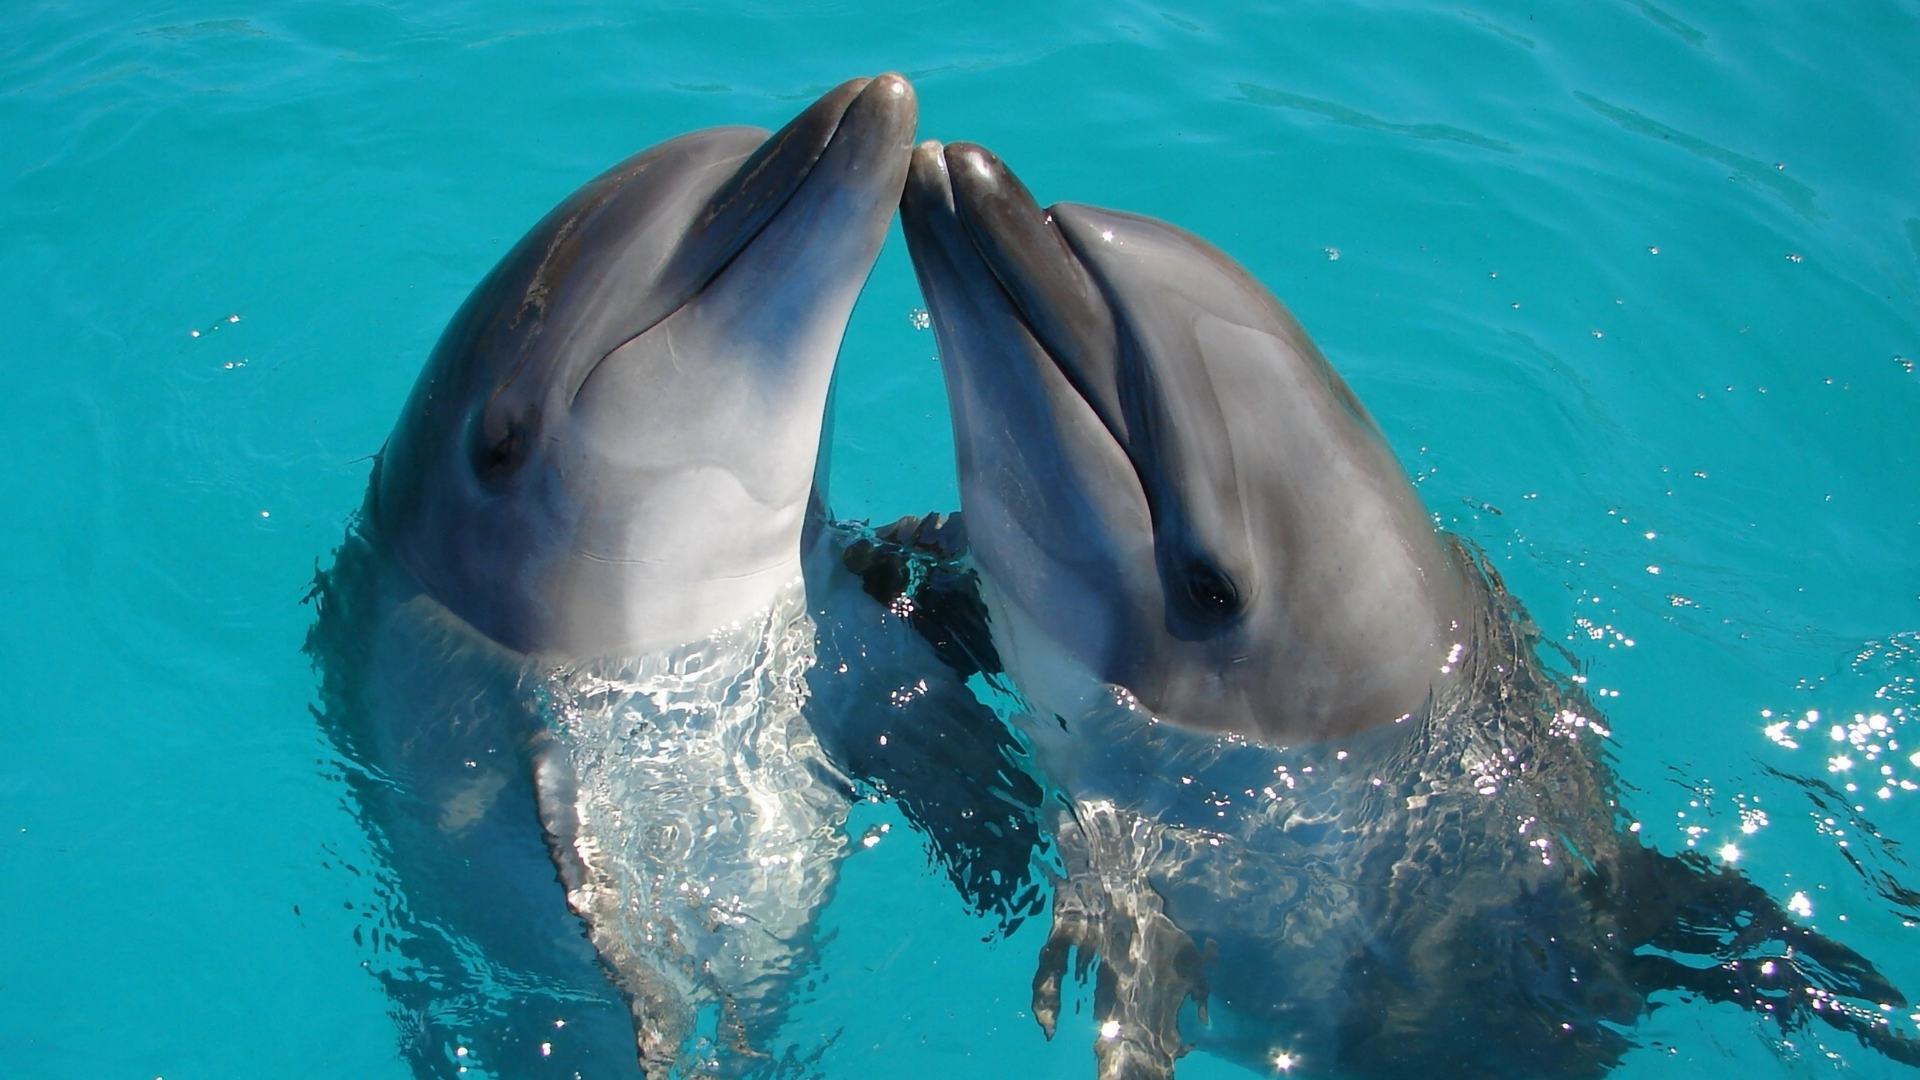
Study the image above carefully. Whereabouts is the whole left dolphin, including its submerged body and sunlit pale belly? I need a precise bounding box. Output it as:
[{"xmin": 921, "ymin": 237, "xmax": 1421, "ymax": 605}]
[{"xmin": 309, "ymin": 75, "xmax": 918, "ymax": 1076}]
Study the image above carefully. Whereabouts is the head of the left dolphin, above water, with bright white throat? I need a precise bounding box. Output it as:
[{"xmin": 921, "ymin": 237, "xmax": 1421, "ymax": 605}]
[{"xmin": 367, "ymin": 75, "xmax": 916, "ymax": 657}]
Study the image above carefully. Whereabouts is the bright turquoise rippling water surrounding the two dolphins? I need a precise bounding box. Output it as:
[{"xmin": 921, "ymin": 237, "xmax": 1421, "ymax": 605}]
[{"xmin": 0, "ymin": 2, "xmax": 1920, "ymax": 1078}]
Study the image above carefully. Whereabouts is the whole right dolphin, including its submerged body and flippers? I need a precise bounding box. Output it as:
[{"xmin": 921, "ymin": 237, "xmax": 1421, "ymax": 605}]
[{"xmin": 891, "ymin": 142, "xmax": 1920, "ymax": 1078}]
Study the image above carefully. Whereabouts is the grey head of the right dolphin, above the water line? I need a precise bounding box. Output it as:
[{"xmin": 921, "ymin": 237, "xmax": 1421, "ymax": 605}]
[{"xmin": 902, "ymin": 142, "xmax": 1471, "ymax": 742}]
